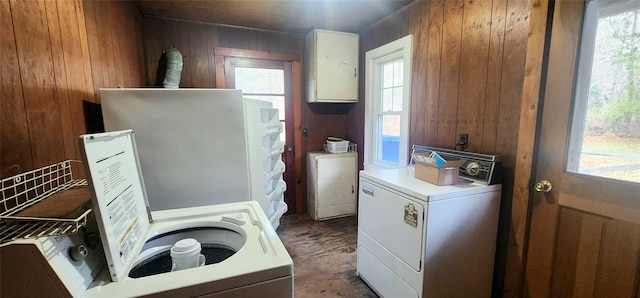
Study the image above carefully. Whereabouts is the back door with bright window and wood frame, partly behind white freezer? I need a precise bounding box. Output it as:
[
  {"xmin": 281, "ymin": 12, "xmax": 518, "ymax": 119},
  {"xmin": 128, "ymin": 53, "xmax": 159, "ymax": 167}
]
[{"xmin": 216, "ymin": 50, "xmax": 296, "ymax": 213}]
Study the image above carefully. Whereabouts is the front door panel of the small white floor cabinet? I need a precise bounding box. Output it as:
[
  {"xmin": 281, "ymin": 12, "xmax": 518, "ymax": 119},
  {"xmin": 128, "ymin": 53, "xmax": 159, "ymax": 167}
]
[{"xmin": 316, "ymin": 155, "xmax": 357, "ymax": 218}]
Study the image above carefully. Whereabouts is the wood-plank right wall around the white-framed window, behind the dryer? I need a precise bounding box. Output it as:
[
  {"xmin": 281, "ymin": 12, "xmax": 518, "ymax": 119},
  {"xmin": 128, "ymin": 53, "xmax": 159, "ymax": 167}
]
[{"xmin": 347, "ymin": 0, "xmax": 530, "ymax": 296}]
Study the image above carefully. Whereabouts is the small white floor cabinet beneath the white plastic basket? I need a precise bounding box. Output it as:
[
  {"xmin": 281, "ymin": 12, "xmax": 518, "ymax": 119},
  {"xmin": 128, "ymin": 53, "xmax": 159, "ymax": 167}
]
[{"xmin": 307, "ymin": 152, "xmax": 358, "ymax": 220}]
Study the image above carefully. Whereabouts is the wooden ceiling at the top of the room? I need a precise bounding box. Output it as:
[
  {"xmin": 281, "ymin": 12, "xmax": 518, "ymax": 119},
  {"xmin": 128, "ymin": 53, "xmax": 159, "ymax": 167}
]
[{"xmin": 135, "ymin": 0, "xmax": 414, "ymax": 34}]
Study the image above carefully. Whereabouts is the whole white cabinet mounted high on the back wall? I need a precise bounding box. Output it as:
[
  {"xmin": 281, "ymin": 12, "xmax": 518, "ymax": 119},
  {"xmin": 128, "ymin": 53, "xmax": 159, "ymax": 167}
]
[{"xmin": 305, "ymin": 29, "xmax": 359, "ymax": 102}]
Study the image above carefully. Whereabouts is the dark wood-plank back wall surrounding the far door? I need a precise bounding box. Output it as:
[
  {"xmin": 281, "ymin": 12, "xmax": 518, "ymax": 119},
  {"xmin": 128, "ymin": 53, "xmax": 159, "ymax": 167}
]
[{"xmin": 144, "ymin": 17, "xmax": 352, "ymax": 213}]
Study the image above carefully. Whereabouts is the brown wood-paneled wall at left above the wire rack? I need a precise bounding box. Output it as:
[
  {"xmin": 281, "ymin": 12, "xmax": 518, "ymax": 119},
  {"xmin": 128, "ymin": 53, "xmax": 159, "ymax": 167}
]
[{"xmin": 0, "ymin": 0, "xmax": 143, "ymax": 178}]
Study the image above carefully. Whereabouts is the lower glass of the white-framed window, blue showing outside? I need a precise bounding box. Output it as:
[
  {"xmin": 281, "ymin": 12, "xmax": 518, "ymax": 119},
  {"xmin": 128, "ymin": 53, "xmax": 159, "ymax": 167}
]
[{"xmin": 378, "ymin": 115, "xmax": 400, "ymax": 164}]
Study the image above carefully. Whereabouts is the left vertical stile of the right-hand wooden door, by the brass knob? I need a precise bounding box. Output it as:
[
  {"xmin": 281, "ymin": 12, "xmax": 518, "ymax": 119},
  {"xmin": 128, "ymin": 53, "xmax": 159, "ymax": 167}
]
[{"xmin": 514, "ymin": 1, "xmax": 585, "ymax": 297}]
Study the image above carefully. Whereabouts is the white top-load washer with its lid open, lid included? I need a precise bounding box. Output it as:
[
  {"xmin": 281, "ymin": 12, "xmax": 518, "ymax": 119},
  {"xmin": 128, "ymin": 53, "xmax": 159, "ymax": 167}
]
[{"xmin": 81, "ymin": 130, "xmax": 293, "ymax": 297}]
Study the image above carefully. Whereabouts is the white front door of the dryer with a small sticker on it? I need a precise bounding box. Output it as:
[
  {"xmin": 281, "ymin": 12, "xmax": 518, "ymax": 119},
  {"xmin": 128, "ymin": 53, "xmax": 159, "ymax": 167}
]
[{"xmin": 358, "ymin": 179, "xmax": 425, "ymax": 271}]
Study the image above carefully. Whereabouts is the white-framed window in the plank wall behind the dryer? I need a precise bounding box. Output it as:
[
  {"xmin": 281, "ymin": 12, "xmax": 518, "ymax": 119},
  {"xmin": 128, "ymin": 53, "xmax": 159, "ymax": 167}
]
[{"xmin": 364, "ymin": 35, "xmax": 412, "ymax": 168}]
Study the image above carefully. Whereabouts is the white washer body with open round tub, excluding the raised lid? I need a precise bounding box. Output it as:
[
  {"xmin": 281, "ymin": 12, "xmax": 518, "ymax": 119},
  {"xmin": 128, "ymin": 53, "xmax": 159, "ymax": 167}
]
[{"xmin": 82, "ymin": 201, "xmax": 293, "ymax": 297}]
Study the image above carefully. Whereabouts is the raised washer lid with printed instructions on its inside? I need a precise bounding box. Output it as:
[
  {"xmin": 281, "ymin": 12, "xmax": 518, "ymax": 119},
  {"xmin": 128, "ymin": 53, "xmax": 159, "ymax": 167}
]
[{"xmin": 80, "ymin": 130, "xmax": 152, "ymax": 281}]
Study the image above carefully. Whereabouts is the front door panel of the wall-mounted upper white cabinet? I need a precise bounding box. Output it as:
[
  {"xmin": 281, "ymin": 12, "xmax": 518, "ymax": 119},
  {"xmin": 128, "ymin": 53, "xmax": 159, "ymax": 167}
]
[{"xmin": 315, "ymin": 31, "xmax": 358, "ymax": 101}]
